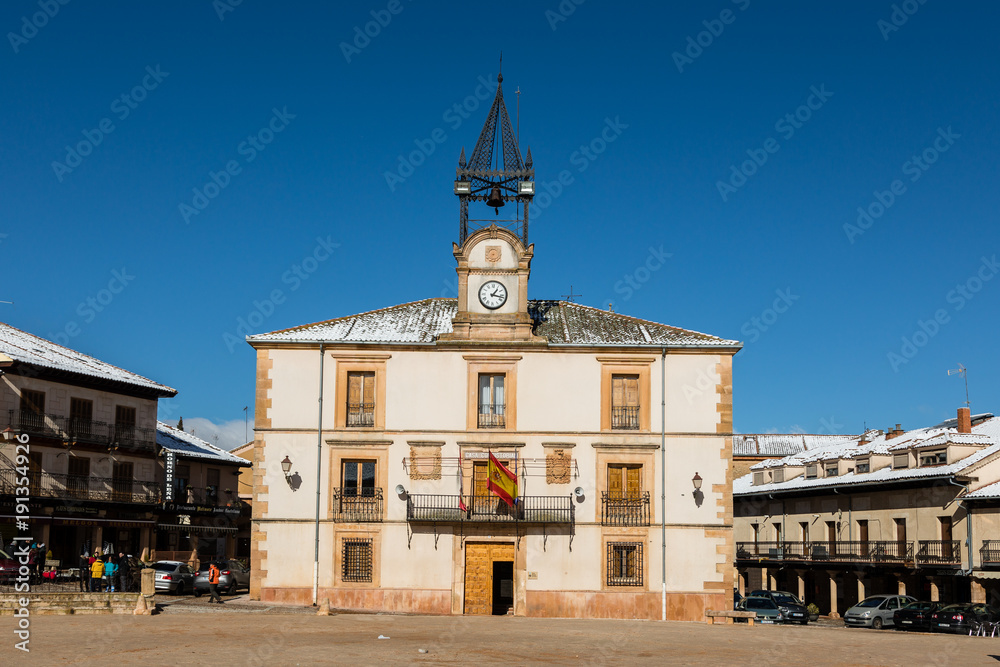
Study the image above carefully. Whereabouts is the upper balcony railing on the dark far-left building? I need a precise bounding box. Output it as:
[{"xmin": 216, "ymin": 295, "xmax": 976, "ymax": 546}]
[{"xmin": 8, "ymin": 410, "xmax": 156, "ymax": 452}]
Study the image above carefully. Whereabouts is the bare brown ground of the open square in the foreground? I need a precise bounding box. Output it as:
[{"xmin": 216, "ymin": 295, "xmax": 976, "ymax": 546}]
[{"xmin": 0, "ymin": 612, "xmax": 1000, "ymax": 667}]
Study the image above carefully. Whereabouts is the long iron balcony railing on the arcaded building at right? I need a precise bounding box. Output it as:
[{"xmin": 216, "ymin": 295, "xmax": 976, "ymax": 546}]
[{"xmin": 736, "ymin": 540, "xmax": 913, "ymax": 563}]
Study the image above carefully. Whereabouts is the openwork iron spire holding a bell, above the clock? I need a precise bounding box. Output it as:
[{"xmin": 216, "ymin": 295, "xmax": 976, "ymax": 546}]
[{"xmin": 455, "ymin": 66, "xmax": 535, "ymax": 247}]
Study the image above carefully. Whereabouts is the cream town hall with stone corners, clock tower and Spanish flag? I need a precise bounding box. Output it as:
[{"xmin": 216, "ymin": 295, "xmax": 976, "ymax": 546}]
[{"xmin": 247, "ymin": 77, "xmax": 741, "ymax": 621}]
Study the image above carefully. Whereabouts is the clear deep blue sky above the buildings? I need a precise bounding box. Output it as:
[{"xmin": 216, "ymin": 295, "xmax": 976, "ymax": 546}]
[{"xmin": 0, "ymin": 0, "xmax": 1000, "ymax": 445}]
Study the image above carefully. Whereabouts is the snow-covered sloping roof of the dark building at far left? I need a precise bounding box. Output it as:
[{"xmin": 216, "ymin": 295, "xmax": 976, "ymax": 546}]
[{"xmin": 0, "ymin": 322, "xmax": 177, "ymax": 396}]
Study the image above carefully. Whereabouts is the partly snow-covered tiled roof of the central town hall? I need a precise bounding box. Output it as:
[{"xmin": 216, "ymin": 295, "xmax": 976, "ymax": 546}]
[{"xmin": 247, "ymin": 298, "xmax": 741, "ymax": 347}]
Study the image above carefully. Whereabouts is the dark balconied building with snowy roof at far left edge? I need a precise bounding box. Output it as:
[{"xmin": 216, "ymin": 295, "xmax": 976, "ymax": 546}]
[{"xmin": 0, "ymin": 323, "xmax": 177, "ymax": 565}]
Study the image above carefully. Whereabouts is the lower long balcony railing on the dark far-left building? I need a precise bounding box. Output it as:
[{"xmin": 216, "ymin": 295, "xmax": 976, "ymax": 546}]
[{"xmin": 0, "ymin": 470, "xmax": 160, "ymax": 504}]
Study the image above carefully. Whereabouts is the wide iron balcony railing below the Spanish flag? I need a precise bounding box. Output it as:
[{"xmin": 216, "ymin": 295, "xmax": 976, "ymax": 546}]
[{"xmin": 406, "ymin": 493, "xmax": 574, "ymax": 523}]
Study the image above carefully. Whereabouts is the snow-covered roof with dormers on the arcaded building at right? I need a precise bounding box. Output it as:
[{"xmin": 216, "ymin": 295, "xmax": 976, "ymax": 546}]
[{"xmin": 733, "ymin": 418, "xmax": 1000, "ymax": 495}]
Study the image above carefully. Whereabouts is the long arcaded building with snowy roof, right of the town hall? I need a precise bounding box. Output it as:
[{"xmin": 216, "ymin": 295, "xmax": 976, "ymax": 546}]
[{"xmin": 733, "ymin": 408, "xmax": 1000, "ymax": 615}]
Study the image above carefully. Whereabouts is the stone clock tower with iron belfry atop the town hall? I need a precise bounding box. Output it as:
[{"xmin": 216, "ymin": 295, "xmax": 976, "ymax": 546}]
[{"xmin": 439, "ymin": 69, "xmax": 544, "ymax": 343}]
